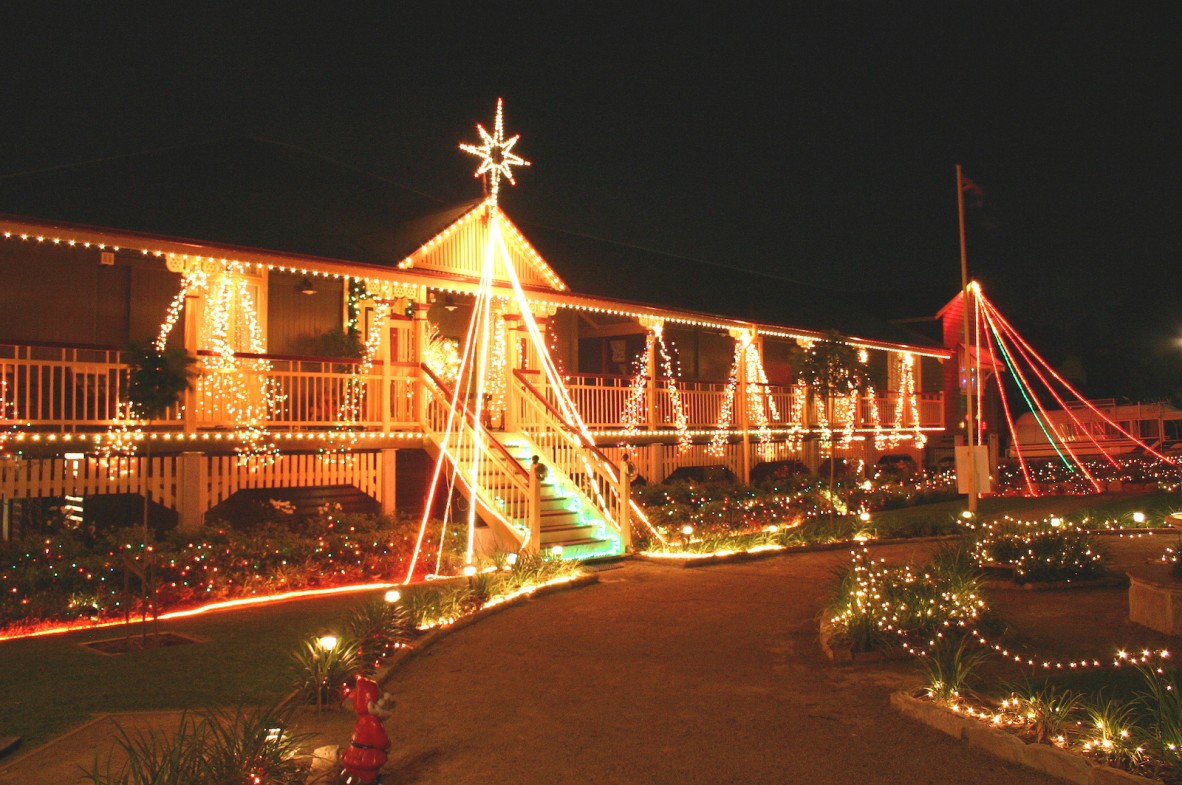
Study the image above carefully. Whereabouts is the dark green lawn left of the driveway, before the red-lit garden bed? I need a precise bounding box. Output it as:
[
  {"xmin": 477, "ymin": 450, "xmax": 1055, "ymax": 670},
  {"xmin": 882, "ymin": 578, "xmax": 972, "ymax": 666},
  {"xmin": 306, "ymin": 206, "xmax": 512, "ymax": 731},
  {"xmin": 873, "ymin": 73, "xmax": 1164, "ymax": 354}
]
[{"xmin": 0, "ymin": 593, "xmax": 381, "ymax": 748}]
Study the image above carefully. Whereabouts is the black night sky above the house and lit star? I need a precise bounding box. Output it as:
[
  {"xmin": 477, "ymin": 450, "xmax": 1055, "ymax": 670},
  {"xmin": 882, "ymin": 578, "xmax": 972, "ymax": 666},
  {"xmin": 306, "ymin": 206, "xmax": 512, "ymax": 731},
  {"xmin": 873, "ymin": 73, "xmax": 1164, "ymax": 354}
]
[{"xmin": 0, "ymin": 2, "xmax": 1182, "ymax": 398}]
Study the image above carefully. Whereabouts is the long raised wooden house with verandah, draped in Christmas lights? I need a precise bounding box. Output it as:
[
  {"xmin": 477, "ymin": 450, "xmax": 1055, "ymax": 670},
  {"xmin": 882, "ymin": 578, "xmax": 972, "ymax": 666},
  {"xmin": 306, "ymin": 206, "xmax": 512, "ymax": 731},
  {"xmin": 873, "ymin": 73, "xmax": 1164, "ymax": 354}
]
[{"xmin": 0, "ymin": 134, "xmax": 953, "ymax": 554}]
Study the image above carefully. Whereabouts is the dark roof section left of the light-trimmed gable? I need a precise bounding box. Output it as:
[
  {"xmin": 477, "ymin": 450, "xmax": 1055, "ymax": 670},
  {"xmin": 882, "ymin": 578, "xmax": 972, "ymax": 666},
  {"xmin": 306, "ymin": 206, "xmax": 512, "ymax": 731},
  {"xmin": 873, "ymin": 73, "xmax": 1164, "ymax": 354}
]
[{"xmin": 0, "ymin": 137, "xmax": 476, "ymax": 265}]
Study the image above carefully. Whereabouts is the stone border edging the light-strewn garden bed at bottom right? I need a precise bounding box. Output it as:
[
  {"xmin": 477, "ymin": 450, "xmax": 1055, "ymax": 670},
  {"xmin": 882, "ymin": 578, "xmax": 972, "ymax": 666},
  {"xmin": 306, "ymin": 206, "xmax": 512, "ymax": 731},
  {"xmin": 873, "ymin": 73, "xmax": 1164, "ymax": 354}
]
[{"xmin": 890, "ymin": 692, "xmax": 1161, "ymax": 785}]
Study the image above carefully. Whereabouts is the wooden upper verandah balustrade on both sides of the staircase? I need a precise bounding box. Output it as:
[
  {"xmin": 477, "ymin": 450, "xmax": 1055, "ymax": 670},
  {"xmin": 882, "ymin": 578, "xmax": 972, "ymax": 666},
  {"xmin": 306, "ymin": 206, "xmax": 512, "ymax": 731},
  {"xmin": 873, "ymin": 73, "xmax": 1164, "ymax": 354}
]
[{"xmin": 0, "ymin": 343, "xmax": 944, "ymax": 432}]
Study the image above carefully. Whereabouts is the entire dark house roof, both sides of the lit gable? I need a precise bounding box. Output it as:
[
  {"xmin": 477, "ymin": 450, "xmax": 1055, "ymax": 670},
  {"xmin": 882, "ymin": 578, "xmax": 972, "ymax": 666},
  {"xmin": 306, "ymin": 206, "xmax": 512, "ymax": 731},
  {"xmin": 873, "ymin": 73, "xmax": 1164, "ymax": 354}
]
[{"xmin": 0, "ymin": 137, "xmax": 935, "ymax": 346}]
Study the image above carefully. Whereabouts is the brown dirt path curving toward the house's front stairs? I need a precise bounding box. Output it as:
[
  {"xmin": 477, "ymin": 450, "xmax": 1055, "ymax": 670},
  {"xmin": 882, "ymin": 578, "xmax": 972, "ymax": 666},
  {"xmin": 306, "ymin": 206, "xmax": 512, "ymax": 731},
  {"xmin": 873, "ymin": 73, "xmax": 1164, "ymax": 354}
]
[{"xmin": 389, "ymin": 546, "xmax": 1053, "ymax": 785}]
